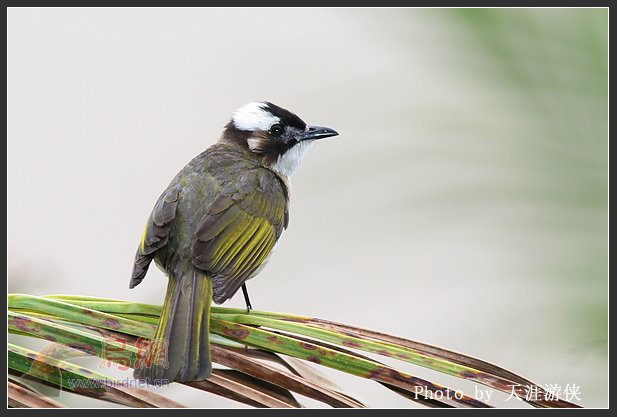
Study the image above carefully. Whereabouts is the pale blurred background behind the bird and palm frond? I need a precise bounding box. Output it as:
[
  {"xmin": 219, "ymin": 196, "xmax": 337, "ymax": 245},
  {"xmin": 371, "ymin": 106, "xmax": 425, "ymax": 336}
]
[{"xmin": 7, "ymin": 8, "xmax": 608, "ymax": 407}]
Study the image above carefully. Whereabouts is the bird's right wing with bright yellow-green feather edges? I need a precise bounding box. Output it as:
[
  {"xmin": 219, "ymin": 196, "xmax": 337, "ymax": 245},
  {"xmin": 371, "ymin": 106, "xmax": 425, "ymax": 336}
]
[{"xmin": 191, "ymin": 173, "xmax": 288, "ymax": 304}]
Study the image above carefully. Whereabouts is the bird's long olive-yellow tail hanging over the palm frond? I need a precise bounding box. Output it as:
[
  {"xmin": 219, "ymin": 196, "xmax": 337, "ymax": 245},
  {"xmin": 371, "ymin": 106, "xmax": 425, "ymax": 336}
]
[{"xmin": 133, "ymin": 270, "xmax": 212, "ymax": 384}]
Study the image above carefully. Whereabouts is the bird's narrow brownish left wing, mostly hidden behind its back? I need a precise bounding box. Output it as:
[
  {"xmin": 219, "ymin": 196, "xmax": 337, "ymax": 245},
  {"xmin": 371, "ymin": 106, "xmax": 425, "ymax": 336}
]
[{"xmin": 129, "ymin": 186, "xmax": 179, "ymax": 288}]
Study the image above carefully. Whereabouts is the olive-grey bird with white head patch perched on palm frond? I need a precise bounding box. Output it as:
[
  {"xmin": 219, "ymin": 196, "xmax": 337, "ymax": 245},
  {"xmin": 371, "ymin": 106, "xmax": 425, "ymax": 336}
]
[{"xmin": 129, "ymin": 101, "xmax": 338, "ymax": 383}]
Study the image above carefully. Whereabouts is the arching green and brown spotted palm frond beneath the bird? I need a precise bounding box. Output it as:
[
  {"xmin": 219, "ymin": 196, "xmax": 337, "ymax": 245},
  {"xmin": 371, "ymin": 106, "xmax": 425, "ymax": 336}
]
[{"xmin": 8, "ymin": 294, "xmax": 576, "ymax": 408}]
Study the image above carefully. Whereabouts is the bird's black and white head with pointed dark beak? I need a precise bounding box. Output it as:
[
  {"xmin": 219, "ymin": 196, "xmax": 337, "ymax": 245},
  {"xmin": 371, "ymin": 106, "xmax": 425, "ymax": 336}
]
[{"xmin": 221, "ymin": 101, "xmax": 338, "ymax": 177}]
